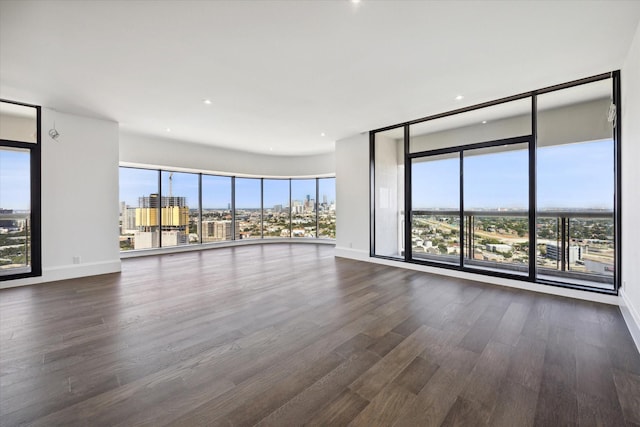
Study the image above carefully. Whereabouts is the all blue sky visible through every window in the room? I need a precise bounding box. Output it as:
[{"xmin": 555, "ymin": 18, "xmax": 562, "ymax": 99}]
[{"xmin": 0, "ymin": 140, "xmax": 614, "ymax": 210}]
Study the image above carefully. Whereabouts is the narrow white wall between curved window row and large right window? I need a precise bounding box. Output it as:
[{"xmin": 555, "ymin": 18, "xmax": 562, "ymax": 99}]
[{"xmin": 335, "ymin": 133, "xmax": 369, "ymax": 259}]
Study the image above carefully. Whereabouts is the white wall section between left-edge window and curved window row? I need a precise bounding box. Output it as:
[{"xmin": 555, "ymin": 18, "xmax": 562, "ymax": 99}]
[{"xmin": 0, "ymin": 108, "xmax": 120, "ymax": 288}]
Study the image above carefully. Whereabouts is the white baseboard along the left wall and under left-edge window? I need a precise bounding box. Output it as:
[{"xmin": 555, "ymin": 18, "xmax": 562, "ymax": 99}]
[{"xmin": 0, "ymin": 260, "xmax": 121, "ymax": 289}]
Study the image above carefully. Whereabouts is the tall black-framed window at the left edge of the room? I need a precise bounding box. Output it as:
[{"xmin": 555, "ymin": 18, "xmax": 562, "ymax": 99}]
[{"xmin": 0, "ymin": 101, "xmax": 42, "ymax": 280}]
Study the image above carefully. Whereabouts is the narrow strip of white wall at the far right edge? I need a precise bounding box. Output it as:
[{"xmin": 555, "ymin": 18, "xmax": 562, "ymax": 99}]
[{"xmin": 621, "ymin": 20, "xmax": 640, "ymax": 349}]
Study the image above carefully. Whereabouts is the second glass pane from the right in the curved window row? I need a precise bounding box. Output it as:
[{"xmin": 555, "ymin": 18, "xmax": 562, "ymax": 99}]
[{"xmin": 291, "ymin": 179, "xmax": 316, "ymax": 237}]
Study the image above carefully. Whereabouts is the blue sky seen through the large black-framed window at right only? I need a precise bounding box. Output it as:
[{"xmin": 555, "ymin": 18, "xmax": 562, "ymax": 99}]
[{"xmin": 411, "ymin": 140, "xmax": 614, "ymax": 210}]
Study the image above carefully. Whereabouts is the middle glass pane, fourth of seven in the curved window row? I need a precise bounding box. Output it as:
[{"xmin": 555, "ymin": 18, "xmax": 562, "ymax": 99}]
[{"xmin": 235, "ymin": 178, "xmax": 262, "ymax": 239}]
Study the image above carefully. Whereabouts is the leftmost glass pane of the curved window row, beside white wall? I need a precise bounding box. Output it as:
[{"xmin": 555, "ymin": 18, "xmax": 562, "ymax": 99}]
[{"xmin": 120, "ymin": 167, "xmax": 160, "ymax": 251}]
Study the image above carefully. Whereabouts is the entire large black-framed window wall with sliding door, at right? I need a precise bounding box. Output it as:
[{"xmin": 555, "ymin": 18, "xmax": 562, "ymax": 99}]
[{"xmin": 371, "ymin": 73, "xmax": 620, "ymax": 292}]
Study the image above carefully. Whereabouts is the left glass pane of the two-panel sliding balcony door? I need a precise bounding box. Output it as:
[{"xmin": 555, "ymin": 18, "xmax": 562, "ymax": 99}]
[{"xmin": 411, "ymin": 153, "xmax": 461, "ymax": 265}]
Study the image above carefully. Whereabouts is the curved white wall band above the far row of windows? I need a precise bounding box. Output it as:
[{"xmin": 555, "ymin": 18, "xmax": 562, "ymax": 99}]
[{"xmin": 120, "ymin": 132, "xmax": 335, "ymax": 177}]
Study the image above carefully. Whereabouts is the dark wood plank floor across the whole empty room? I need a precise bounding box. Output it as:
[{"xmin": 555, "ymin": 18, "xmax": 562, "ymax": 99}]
[{"xmin": 0, "ymin": 244, "xmax": 640, "ymax": 426}]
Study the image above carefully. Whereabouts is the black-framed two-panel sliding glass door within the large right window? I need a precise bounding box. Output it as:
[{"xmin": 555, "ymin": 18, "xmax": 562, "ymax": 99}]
[{"xmin": 410, "ymin": 137, "xmax": 530, "ymax": 275}]
